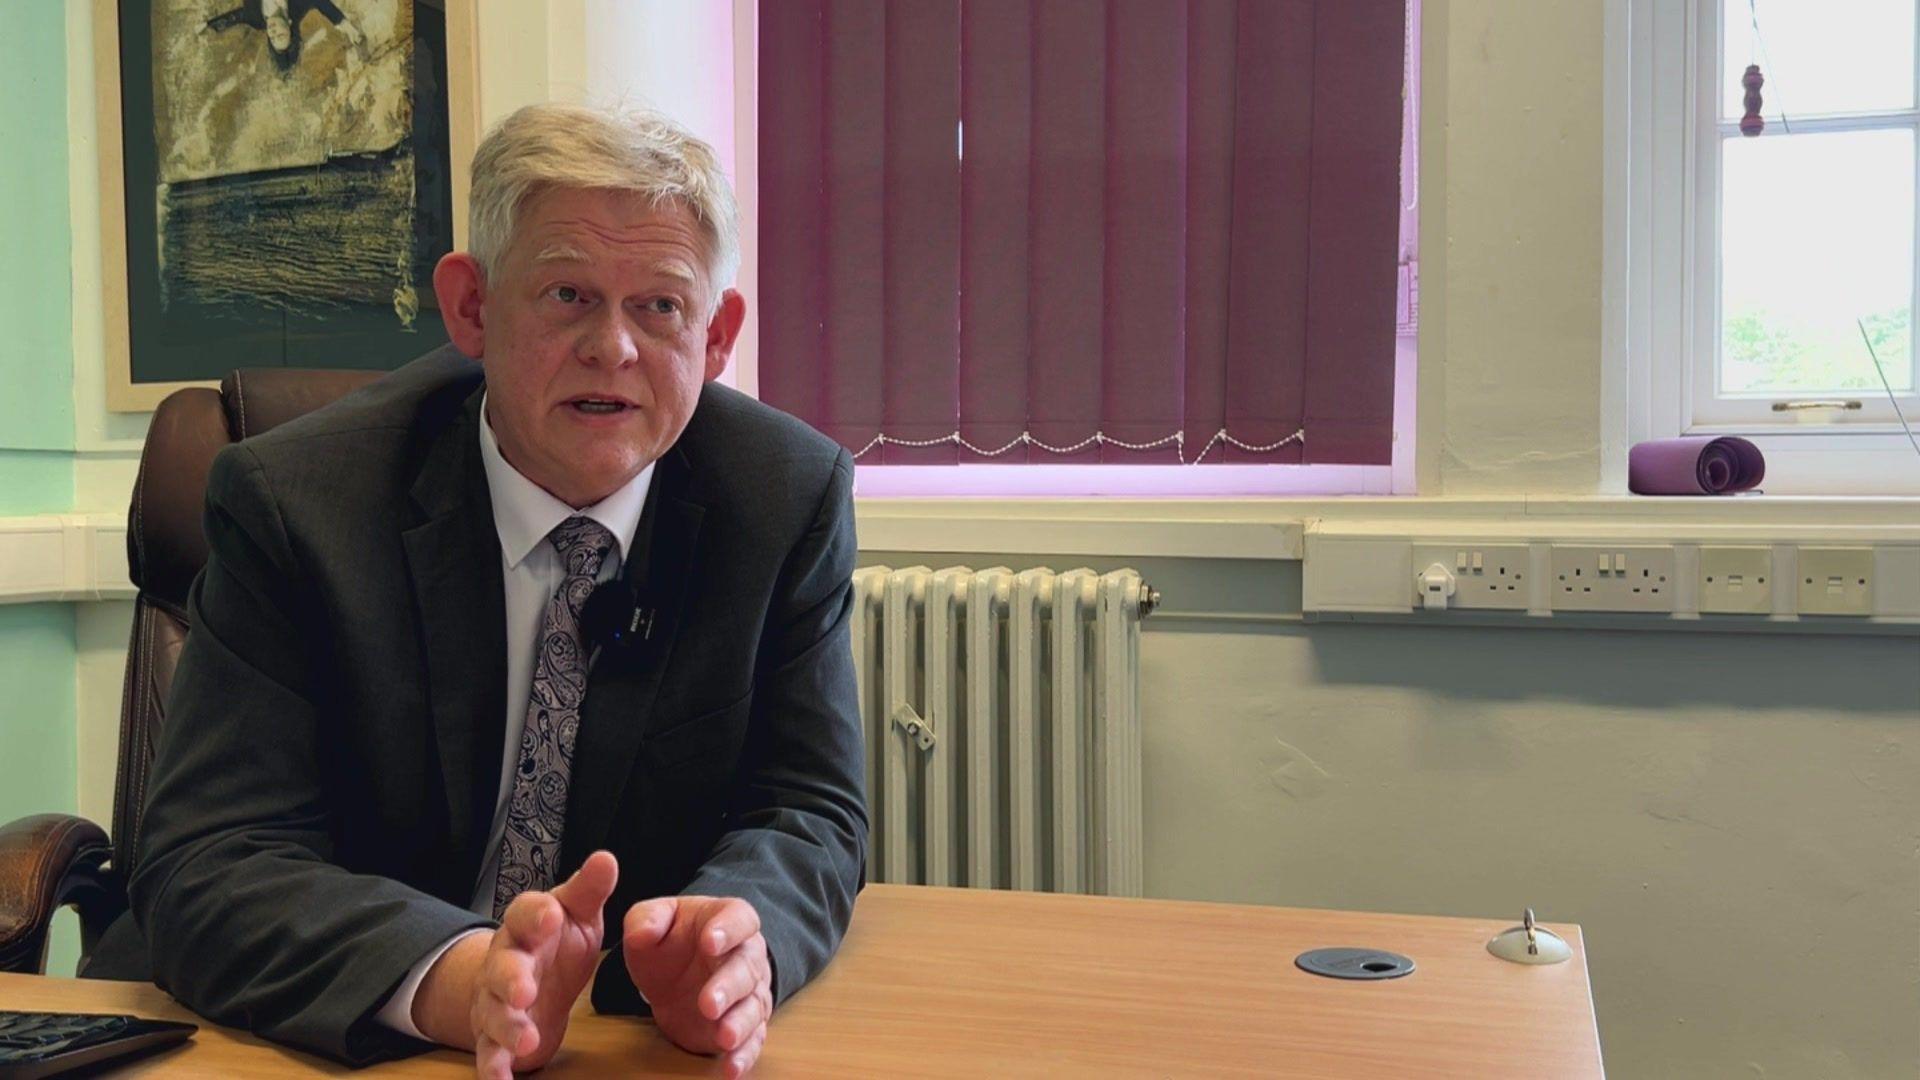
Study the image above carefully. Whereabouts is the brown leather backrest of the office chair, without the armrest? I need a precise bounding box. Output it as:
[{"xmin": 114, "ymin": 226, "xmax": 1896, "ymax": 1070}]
[{"xmin": 113, "ymin": 369, "xmax": 380, "ymax": 874}]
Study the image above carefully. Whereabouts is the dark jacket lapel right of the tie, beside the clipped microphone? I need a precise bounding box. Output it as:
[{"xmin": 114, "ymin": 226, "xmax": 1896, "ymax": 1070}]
[{"xmin": 559, "ymin": 448, "xmax": 707, "ymax": 864}]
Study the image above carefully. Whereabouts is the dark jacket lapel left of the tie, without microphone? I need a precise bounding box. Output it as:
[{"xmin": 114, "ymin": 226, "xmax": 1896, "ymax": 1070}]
[{"xmin": 405, "ymin": 390, "xmax": 507, "ymax": 883}]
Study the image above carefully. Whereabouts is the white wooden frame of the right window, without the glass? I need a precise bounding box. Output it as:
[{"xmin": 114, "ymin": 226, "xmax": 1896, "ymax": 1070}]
[{"xmin": 1605, "ymin": 0, "xmax": 1920, "ymax": 494}]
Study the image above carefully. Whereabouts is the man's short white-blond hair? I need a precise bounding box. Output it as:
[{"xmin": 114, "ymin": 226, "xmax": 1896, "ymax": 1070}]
[{"xmin": 467, "ymin": 104, "xmax": 739, "ymax": 296}]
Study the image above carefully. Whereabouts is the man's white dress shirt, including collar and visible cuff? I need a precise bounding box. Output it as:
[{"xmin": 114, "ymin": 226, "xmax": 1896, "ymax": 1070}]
[{"xmin": 378, "ymin": 398, "xmax": 653, "ymax": 1038}]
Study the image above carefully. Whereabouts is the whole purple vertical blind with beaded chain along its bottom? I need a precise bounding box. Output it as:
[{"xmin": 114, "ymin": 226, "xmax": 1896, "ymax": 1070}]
[{"xmin": 758, "ymin": 0, "xmax": 1407, "ymax": 465}]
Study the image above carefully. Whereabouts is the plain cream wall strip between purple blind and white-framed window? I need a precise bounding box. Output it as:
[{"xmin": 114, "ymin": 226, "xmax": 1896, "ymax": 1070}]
[{"xmin": 1417, "ymin": 0, "xmax": 1605, "ymax": 496}]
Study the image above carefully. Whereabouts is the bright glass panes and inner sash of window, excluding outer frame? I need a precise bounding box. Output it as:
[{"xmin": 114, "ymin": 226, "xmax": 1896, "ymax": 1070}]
[{"xmin": 1693, "ymin": 0, "xmax": 1920, "ymax": 423}]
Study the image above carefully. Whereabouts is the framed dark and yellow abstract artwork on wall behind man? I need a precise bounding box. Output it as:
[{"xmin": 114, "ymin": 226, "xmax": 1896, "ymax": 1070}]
[{"xmin": 94, "ymin": 0, "xmax": 478, "ymax": 411}]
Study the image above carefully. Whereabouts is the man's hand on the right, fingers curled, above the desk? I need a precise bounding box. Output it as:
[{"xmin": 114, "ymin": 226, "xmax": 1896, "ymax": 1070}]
[{"xmin": 622, "ymin": 896, "xmax": 774, "ymax": 1080}]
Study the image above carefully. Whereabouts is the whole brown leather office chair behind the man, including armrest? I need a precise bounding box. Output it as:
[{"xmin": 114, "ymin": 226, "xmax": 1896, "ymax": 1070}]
[{"xmin": 0, "ymin": 369, "xmax": 378, "ymax": 974}]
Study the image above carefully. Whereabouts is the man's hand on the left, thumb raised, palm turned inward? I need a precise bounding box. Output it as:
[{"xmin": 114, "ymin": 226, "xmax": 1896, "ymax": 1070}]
[{"xmin": 413, "ymin": 851, "xmax": 620, "ymax": 1080}]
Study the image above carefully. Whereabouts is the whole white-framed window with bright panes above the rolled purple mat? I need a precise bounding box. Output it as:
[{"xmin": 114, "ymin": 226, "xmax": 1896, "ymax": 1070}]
[{"xmin": 1609, "ymin": 0, "xmax": 1920, "ymax": 494}]
